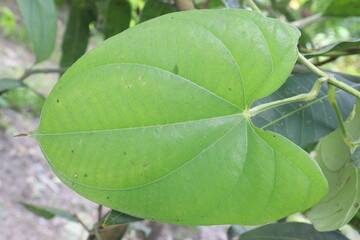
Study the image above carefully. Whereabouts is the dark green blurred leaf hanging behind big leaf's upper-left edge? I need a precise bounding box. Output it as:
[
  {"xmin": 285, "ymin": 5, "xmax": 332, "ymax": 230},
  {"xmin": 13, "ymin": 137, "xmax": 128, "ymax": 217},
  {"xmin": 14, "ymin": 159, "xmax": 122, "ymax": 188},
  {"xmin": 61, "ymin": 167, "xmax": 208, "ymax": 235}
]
[{"xmin": 104, "ymin": 0, "xmax": 131, "ymax": 38}]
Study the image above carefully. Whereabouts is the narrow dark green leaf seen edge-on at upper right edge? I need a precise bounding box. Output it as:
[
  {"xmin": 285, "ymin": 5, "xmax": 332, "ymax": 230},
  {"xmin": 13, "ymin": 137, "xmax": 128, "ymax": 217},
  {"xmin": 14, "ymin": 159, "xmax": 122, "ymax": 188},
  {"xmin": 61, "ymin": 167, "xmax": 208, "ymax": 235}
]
[{"xmin": 304, "ymin": 38, "xmax": 360, "ymax": 58}]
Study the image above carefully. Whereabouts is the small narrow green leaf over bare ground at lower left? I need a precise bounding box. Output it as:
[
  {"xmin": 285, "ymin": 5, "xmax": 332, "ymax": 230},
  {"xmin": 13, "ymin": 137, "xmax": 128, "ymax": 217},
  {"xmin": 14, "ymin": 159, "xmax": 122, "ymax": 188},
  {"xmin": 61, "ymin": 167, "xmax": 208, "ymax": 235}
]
[{"xmin": 20, "ymin": 202, "xmax": 78, "ymax": 222}]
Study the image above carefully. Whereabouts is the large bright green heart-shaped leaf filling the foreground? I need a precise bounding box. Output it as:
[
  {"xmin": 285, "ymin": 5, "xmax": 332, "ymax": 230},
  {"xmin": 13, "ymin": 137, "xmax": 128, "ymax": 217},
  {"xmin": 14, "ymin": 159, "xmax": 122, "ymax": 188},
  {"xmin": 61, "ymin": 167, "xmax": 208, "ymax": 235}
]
[{"xmin": 32, "ymin": 9, "xmax": 327, "ymax": 225}]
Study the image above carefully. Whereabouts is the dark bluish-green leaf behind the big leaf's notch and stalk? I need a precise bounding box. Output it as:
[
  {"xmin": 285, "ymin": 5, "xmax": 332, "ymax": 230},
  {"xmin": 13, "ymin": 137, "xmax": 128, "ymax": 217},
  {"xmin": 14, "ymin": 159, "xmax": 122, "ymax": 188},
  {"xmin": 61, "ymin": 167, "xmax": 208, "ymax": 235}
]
[{"xmin": 252, "ymin": 73, "xmax": 360, "ymax": 148}]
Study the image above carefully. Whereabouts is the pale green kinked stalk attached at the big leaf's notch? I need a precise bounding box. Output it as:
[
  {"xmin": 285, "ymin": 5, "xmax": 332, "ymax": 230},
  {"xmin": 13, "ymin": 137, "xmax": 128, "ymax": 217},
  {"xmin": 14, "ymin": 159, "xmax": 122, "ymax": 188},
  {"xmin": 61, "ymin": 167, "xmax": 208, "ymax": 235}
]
[{"xmin": 247, "ymin": 76, "xmax": 329, "ymax": 116}]
